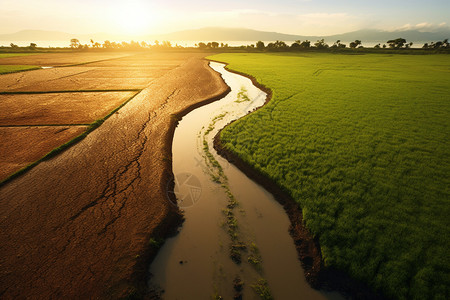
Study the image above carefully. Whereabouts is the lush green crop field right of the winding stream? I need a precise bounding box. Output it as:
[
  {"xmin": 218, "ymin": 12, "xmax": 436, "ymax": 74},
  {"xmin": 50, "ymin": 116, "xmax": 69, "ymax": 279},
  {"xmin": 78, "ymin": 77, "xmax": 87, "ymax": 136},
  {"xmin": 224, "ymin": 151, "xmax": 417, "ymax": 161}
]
[{"xmin": 210, "ymin": 53, "xmax": 450, "ymax": 299}]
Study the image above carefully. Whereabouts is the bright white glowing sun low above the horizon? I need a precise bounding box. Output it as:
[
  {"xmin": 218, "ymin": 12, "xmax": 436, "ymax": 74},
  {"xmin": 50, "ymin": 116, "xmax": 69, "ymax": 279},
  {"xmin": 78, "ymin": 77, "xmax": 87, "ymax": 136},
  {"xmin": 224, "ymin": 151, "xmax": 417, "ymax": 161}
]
[{"xmin": 112, "ymin": 0, "xmax": 159, "ymax": 35}]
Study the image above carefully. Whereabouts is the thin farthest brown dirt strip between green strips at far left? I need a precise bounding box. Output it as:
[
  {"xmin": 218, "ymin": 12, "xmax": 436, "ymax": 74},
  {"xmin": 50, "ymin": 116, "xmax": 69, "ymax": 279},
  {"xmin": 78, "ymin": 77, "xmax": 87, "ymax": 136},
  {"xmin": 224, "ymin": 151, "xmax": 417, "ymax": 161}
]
[{"xmin": 0, "ymin": 52, "xmax": 131, "ymax": 66}]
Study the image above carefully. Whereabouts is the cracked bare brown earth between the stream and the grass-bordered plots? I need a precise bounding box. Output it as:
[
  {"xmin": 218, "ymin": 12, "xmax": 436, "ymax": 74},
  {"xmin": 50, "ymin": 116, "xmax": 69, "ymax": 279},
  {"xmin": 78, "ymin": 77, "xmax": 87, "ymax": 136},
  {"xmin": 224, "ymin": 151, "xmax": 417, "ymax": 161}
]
[{"xmin": 0, "ymin": 53, "xmax": 229, "ymax": 299}]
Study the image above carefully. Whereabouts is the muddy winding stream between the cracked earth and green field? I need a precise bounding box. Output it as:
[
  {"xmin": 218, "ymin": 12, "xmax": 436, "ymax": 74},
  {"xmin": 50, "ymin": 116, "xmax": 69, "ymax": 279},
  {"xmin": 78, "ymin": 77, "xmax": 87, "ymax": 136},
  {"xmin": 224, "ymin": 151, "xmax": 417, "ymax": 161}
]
[{"xmin": 149, "ymin": 62, "xmax": 340, "ymax": 299}]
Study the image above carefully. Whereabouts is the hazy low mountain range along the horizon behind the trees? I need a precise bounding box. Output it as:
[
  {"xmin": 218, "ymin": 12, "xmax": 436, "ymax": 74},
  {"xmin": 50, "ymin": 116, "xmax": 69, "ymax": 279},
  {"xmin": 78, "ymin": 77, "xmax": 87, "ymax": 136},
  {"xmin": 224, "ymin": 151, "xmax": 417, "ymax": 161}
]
[{"xmin": 0, "ymin": 27, "xmax": 450, "ymax": 43}]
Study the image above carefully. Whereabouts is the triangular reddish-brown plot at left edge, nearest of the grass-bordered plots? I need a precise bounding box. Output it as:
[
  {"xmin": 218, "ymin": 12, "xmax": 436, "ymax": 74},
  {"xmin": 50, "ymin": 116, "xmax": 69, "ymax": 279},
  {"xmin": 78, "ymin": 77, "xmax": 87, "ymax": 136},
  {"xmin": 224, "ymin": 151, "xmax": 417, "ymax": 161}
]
[{"xmin": 0, "ymin": 126, "xmax": 87, "ymax": 181}]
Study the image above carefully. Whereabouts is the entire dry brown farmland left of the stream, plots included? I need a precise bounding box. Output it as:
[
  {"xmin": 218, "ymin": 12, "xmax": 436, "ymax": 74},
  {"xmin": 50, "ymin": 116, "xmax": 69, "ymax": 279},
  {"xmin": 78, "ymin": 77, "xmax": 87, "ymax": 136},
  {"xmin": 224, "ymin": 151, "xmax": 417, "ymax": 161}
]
[{"xmin": 0, "ymin": 53, "xmax": 228, "ymax": 299}]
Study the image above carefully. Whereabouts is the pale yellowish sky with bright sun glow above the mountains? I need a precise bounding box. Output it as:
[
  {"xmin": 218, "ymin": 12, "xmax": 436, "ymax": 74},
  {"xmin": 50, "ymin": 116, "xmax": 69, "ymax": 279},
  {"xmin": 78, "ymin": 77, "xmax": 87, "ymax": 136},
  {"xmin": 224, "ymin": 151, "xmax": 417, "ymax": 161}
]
[{"xmin": 0, "ymin": 0, "xmax": 450, "ymax": 36}]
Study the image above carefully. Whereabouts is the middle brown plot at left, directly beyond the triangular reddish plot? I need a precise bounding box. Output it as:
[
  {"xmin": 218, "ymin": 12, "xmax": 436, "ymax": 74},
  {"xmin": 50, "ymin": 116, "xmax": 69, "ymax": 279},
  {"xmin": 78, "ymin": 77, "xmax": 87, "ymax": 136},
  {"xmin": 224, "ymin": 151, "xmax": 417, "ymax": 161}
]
[{"xmin": 0, "ymin": 92, "xmax": 136, "ymax": 126}]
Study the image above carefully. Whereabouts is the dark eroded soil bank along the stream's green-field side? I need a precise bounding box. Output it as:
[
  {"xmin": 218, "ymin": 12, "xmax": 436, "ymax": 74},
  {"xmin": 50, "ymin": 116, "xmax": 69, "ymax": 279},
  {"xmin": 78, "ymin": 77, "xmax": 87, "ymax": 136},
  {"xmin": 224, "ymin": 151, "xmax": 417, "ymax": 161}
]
[{"xmin": 214, "ymin": 62, "xmax": 385, "ymax": 300}]
